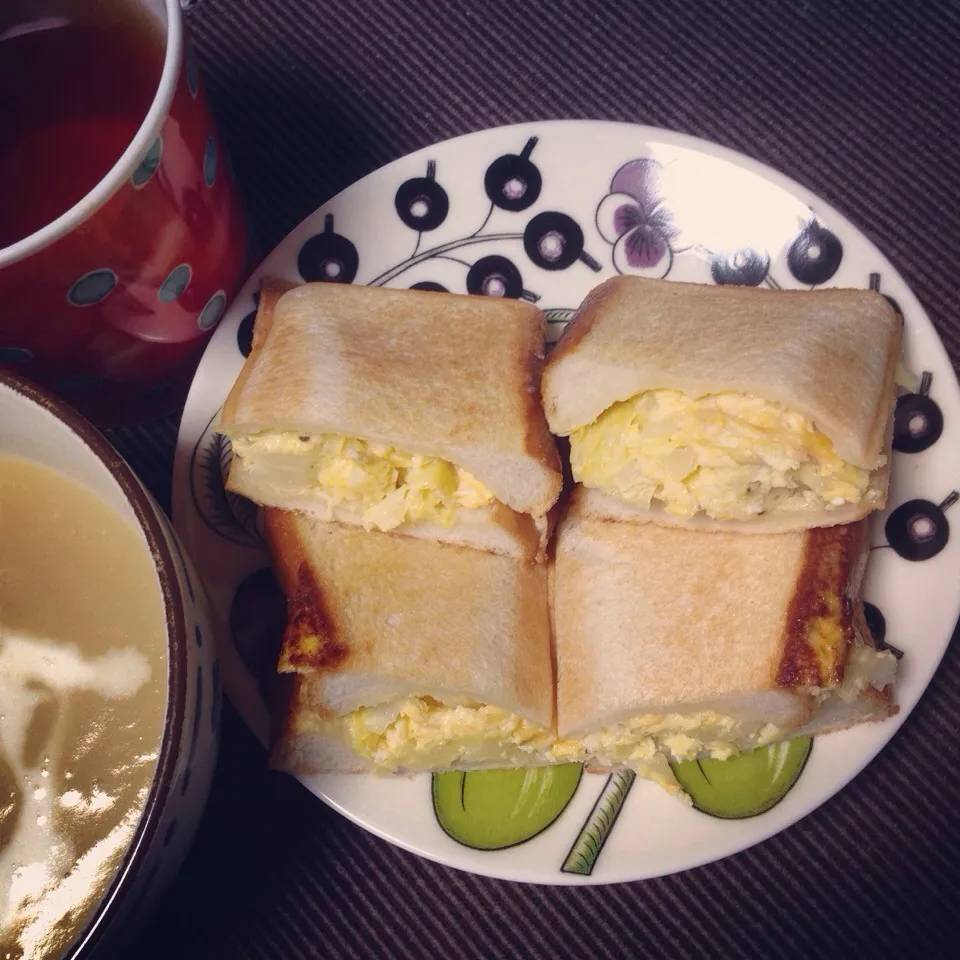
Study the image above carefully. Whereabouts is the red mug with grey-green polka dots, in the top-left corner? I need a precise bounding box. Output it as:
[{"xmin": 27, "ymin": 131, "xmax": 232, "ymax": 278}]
[{"xmin": 0, "ymin": 0, "xmax": 247, "ymax": 426}]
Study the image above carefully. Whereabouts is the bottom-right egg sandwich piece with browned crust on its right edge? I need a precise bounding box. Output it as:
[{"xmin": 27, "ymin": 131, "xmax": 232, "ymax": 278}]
[{"xmin": 553, "ymin": 491, "xmax": 897, "ymax": 792}]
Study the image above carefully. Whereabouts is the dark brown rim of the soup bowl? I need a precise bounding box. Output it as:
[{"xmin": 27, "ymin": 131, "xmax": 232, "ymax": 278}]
[{"xmin": 0, "ymin": 370, "xmax": 188, "ymax": 960}]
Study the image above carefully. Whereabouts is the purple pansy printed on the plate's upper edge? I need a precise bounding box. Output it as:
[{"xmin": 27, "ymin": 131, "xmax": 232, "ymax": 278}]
[{"xmin": 597, "ymin": 158, "xmax": 679, "ymax": 278}]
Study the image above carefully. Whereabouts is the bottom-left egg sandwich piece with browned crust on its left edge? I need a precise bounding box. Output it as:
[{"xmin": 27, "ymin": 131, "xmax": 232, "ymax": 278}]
[{"xmin": 265, "ymin": 509, "xmax": 557, "ymax": 774}]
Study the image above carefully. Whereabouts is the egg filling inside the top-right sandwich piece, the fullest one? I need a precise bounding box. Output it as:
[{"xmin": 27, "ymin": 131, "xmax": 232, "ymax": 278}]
[{"xmin": 570, "ymin": 390, "xmax": 879, "ymax": 520}]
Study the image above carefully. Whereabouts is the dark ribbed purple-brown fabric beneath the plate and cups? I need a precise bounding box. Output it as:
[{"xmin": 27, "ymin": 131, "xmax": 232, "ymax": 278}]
[{"xmin": 112, "ymin": 0, "xmax": 960, "ymax": 958}]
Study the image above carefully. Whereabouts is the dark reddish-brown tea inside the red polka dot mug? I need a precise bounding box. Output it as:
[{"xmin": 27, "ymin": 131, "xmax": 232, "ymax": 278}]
[{"xmin": 0, "ymin": 0, "xmax": 164, "ymax": 249}]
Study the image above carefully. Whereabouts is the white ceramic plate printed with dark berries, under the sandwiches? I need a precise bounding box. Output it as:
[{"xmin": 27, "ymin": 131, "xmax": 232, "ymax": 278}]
[{"xmin": 174, "ymin": 121, "xmax": 960, "ymax": 883}]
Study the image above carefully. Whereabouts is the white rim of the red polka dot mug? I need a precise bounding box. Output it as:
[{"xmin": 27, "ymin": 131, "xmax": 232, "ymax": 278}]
[{"xmin": 0, "ymin": 0, "xmax": 184, "ymax": 269}]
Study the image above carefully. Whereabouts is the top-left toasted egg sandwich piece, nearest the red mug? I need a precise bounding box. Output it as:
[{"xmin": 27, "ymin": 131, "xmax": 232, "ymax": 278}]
[{"xmin": 217, "ymin": 283, "xmax": 562, "ymax": 559}]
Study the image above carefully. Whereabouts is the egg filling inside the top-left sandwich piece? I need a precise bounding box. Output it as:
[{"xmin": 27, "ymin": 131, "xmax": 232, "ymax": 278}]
[{"xmin": 233, "ymin": 432, "xmax": 494, "ymax": 530}]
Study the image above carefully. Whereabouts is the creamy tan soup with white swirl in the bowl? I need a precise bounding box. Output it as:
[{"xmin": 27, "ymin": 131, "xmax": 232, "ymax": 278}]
[{"xmin": 0, "ymin": 456, "xmax": 167, "ymax": 960}]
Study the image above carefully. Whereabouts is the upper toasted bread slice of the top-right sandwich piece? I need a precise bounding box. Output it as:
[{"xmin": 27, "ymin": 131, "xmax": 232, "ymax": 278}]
[{"xmin": 543, "ymin": 277, "xmax": 901, "ymax": 470}]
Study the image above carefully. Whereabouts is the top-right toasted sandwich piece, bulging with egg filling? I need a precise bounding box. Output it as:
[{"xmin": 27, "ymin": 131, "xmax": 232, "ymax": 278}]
[{"xmin": 542, "ymin": 277, "xmax": 900, "ymax": 533}]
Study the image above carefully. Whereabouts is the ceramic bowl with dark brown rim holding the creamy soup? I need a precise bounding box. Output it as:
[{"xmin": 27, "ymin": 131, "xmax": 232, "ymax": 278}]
[{"xmin": 0, "ymin": 373, "xmax": 221, "ymax": 960}]
